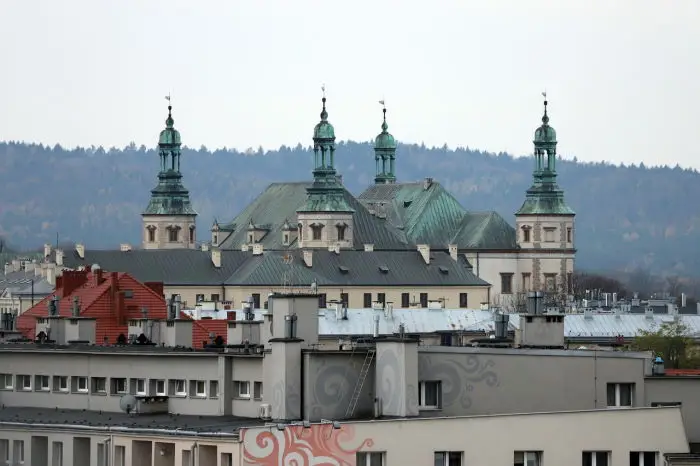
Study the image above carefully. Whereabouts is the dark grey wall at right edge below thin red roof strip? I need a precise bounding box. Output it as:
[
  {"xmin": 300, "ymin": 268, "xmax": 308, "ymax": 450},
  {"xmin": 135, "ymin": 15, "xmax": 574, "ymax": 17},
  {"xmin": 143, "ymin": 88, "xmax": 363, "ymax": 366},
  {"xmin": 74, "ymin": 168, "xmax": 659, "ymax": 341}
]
[{"xmin": 645, "ymin": 376, "xmax": 700, "ymax": 443}]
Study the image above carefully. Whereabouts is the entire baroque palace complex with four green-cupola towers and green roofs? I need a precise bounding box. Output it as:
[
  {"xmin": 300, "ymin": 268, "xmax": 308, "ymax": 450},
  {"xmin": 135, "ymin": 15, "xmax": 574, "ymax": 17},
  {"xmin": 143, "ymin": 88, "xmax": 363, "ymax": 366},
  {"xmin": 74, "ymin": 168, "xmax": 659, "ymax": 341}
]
[{"xmin": 53, "ymin": 95, "xmax": 576, "ymax": 308}]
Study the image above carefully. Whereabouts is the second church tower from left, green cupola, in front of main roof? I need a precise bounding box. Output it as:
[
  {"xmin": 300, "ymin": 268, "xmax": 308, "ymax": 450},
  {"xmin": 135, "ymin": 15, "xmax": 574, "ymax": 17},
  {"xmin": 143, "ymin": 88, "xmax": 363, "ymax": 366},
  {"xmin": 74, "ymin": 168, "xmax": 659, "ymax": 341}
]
[{"xmin": 298, "ymin": 88, "xmax": 355, "ymax": 248}]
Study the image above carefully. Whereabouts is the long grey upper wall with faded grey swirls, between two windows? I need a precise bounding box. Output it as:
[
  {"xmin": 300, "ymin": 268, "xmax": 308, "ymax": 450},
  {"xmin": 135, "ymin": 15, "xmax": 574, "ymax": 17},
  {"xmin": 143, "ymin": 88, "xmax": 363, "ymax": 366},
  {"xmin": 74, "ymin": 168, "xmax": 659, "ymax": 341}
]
[{"xmin": 418, "ymin": 347, "xmax": 649, "ymax": 416}]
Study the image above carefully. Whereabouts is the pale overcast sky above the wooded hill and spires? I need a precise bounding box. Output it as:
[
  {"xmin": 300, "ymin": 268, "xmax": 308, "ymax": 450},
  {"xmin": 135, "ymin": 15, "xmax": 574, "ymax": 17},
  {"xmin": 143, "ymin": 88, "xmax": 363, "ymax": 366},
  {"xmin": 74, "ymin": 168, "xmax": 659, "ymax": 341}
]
[{"xmin": 0, "ymin": 0, "xmax": 700, "ymax": 168}]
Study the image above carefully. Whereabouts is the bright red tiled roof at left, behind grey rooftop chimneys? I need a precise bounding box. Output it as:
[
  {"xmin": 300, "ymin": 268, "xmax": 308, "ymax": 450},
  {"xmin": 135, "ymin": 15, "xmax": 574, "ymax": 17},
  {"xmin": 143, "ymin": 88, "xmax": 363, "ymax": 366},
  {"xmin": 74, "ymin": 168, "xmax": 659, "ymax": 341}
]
[{"xmin": 17, "ymin": 271, "xmax": 167, "ymax": 343}]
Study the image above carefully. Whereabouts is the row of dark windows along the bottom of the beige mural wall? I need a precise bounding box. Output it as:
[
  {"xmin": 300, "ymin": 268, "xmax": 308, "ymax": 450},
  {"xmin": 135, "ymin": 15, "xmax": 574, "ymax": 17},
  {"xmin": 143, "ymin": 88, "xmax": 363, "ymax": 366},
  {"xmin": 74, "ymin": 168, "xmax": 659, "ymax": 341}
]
[{"xmin": 355, "ymin": 451, "xmax": 659, "ymax": 466}]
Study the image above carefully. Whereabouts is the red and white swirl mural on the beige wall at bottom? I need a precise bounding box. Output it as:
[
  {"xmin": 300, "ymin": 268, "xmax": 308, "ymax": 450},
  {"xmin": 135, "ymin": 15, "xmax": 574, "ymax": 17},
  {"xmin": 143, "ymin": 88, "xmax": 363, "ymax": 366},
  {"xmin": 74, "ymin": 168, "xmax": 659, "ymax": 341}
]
[{"xmin": 241, "ymin": 424, "xmax": 374, "ymax": 466}]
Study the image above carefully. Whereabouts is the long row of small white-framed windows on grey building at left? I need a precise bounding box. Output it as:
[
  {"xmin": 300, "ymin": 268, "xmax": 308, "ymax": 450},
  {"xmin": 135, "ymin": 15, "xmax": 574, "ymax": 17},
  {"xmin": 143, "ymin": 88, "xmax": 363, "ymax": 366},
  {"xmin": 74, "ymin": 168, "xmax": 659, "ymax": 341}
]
[{"xmin": 0, "ymin": 374, "xmax": 263, "ymax": 400}]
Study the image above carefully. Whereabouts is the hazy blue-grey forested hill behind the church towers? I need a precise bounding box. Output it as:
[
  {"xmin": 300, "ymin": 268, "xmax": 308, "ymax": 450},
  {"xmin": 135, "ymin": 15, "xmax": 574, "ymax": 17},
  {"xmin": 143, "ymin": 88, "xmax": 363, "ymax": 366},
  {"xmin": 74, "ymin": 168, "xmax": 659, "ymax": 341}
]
[{"xmin": 0, "ymin": 142, "xmax": 700, "ymax": 276}]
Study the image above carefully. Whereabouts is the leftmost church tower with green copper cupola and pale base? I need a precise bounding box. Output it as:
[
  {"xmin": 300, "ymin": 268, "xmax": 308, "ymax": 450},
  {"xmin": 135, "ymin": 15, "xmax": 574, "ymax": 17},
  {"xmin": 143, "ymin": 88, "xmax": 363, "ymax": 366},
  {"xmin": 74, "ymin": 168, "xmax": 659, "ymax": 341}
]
[{"xmin": 142, "ymin": 97, "xmax": 197, "ymax": 249}]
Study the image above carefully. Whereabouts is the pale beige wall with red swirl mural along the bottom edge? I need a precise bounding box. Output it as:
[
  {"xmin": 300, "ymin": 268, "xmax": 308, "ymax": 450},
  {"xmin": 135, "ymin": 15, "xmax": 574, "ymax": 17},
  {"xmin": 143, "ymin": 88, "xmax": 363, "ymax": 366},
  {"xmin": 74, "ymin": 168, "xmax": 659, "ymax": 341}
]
[{"xmin": 241, "ymin": 408, "xmax": 688, "ymax": 466}]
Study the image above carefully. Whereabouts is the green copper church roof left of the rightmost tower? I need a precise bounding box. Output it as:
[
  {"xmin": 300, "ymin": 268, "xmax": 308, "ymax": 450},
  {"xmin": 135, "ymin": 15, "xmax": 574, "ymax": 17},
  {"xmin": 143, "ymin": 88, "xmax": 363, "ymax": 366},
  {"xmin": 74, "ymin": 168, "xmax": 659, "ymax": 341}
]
[{"xmin": 358, "ymin": 179, "xmax": 517, "ymax": 249}]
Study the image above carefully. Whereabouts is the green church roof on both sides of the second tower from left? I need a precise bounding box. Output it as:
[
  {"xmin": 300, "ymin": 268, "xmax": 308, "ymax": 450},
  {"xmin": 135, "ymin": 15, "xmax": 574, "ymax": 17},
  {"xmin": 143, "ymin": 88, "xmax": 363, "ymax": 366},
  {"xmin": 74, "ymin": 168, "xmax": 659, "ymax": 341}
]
[{"xmin": 219, "ymin": 182, "xmax": 407, "ymax": 249}]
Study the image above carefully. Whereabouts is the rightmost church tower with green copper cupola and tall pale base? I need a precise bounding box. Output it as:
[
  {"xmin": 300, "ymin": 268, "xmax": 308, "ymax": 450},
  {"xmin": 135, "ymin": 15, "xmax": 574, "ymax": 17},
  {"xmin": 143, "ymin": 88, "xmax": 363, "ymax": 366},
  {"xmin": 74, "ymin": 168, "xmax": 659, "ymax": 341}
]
[{"xmin": 515, "ymin": 93, "xmax": 576, "ymax": 293}]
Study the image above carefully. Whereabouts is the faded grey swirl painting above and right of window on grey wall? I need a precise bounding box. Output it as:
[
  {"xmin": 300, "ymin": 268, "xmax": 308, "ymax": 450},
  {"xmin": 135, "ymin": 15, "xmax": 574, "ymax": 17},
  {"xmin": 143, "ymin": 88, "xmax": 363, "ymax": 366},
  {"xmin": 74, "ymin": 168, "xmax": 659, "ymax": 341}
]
[{"xmin": 418, "ymin": 354, "xmax": 500, "ymax": 414}]
